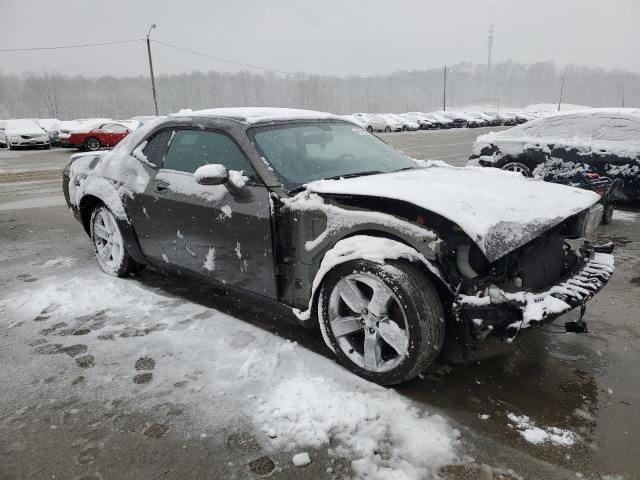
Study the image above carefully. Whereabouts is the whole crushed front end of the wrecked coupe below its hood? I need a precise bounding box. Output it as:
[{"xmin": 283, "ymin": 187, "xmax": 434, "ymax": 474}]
[{"xmin": 444, "ymin": 210, "xmax": 614, "ymax": 340}]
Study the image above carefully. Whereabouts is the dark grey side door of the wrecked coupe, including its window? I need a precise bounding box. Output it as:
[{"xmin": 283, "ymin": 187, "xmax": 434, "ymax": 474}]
[{"xmin": 136, "ymin": 128, "xmax": 276, "ymax": 298}]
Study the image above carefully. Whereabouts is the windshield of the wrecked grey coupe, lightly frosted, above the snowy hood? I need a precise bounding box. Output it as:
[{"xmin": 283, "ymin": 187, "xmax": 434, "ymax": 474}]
[{"xmin": 250, "ymin": 122, "xmax": 416, "ymax": 190}]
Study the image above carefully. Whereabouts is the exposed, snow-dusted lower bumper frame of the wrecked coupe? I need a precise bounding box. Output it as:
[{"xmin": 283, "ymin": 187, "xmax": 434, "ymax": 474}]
[{"xmin": 454, "ymin": 247, "xmax": 614, "ymax": 340}]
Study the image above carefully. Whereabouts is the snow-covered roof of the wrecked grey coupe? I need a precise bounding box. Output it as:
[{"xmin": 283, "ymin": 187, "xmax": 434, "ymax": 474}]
[{"xmin": 170, "ymin": 107, "xmax": 341, "ymax": 125}]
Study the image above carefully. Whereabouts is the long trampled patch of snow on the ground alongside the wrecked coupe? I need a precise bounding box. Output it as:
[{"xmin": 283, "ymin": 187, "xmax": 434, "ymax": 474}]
[{"xmin": 0, "ymin": 258, "xmax": 460, "ymax": 479}]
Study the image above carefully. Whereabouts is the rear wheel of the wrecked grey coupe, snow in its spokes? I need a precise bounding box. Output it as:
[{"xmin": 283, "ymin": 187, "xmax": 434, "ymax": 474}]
[{"xmin": 90, "ymin": 205, "xmax": 136, "ymax": 277}]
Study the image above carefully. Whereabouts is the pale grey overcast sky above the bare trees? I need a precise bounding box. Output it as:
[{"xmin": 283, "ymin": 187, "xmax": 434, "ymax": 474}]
[{"xmin": 0, "ymin": 0, "xmax": 640, "ymax": 76}]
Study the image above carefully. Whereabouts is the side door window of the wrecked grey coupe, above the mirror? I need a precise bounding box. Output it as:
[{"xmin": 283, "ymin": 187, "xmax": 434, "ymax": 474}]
[{"xmin": 162, "ymin": 130, "xmax": 255, "ymax": 178}]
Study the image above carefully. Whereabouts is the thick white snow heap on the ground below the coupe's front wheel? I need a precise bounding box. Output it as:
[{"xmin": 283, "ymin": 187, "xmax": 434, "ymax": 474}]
[{"xmin": 254, "ymin": 376, "xmax": 459, "ymax": 479}]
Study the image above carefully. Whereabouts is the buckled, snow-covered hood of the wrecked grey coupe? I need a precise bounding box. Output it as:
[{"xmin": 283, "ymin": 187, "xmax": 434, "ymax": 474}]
[{"xmin": 306, "ymin": 162, "xmax": 600, "ymax": 262}]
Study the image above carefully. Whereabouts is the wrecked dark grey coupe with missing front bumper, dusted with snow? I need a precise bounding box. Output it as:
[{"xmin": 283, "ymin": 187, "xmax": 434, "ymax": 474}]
[{"xmin": 63, "ymin": 108, "xmax": 614, "ymax": 384}]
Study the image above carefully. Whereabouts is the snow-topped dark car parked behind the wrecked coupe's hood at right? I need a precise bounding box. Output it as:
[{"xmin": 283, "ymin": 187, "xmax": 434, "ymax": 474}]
[{"xmin": 469, "ymin": 108, "xmax": 640, "ymax": 200}]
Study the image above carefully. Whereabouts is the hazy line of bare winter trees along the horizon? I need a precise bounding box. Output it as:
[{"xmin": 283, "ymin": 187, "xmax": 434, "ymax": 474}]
[{"xmin": 0, "ymin": 61, "xmax": 640, "ymax": 119}]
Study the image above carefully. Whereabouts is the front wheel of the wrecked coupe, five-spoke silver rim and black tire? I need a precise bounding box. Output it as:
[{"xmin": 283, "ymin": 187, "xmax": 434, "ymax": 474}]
[{"xmin": 318, "ymin": 260, "xmax": 445, "ymax": 385}]
